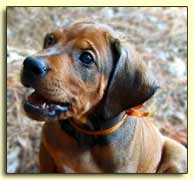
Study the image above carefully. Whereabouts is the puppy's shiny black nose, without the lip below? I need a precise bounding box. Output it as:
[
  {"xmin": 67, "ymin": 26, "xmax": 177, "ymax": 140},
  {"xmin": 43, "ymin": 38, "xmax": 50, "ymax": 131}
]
[{"xmin": 23, "ymin": 57, "xmax": 47, "ymax": 78}]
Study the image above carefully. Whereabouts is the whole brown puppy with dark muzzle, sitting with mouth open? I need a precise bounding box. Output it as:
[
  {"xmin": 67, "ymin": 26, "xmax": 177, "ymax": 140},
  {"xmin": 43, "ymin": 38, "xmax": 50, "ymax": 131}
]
[{"xmin": 21, "ymin": 22, "xmax": 187, "ymax": 173}]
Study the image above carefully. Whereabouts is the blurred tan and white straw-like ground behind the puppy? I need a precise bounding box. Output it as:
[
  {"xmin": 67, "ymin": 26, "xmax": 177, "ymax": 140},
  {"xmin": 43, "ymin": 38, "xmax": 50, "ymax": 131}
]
[{"xmin": 7, "ymin": 7, "xmax": 187, "ymax": 173}]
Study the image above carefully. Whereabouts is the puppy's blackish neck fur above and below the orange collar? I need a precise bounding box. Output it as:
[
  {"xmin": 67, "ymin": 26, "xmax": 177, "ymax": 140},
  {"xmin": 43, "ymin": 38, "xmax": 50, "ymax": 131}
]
[{"xmin": 59, "ymin": 112, "xmax": 135, "ymax": 148}]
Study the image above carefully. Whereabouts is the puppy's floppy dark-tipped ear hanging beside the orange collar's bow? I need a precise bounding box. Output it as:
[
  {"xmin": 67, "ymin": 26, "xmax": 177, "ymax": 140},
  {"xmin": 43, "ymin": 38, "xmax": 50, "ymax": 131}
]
[{"xmin": 104, "ymin": 39, "xmax": 158, "ymax": 118}]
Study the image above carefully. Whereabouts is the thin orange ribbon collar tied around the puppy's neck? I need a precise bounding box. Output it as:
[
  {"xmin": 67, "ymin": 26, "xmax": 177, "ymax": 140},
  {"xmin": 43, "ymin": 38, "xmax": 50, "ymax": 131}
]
[{"xmin": 70, "ymin": 104, "xmax": 149, "ymax": 136}]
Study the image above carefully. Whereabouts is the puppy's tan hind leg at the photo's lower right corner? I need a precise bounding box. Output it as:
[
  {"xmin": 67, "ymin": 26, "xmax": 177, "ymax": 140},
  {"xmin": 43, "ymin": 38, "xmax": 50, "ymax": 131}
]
[{"xmin": 157, "ymin": 138, "xmax": 187, "ymax": 173}]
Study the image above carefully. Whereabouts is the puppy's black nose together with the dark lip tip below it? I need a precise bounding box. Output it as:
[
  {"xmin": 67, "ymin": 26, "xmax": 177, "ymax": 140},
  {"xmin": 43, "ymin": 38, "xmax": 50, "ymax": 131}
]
[{"xmin": 22, "ymin": 56, "xmax": 48, "ymax": 87}]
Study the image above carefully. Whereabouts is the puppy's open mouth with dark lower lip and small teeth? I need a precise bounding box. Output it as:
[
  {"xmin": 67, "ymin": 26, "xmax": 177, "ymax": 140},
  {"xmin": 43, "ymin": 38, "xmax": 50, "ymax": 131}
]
[{"xmin": 24, "ymin": 91, "xmax": 71, "ymax": 120}]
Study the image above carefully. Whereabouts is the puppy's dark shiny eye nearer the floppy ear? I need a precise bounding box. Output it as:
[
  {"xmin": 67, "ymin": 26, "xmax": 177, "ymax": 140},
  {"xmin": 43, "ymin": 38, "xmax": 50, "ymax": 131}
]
[{"xmin": 79, "ymin": 51, "xmax": 95, "ymax": 67}]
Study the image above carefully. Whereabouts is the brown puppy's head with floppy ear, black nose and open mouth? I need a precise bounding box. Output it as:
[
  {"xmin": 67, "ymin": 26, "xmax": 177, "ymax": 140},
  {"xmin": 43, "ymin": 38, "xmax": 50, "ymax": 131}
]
[{"xmin": 21, "ymin": 22, "xmax": 158, "ymax": 123}]
